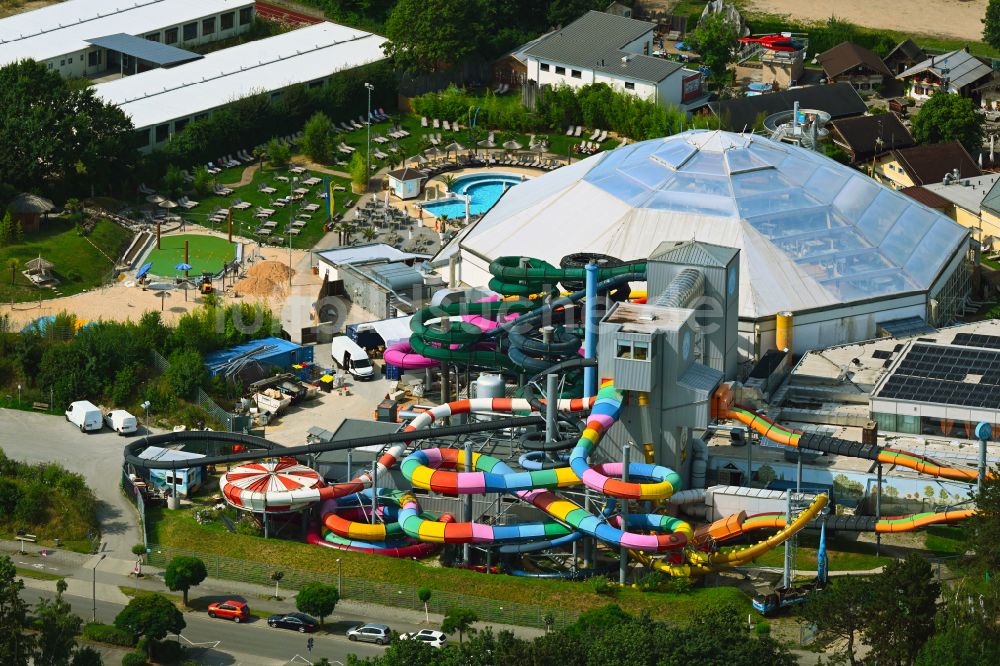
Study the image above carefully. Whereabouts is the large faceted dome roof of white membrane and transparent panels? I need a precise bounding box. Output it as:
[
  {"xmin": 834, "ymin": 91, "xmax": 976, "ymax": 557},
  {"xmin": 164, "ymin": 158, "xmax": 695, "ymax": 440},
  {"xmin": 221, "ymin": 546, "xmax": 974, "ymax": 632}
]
[{"xmin": 441, "ymin": 130, "xmax": 967, "ymax": 317}]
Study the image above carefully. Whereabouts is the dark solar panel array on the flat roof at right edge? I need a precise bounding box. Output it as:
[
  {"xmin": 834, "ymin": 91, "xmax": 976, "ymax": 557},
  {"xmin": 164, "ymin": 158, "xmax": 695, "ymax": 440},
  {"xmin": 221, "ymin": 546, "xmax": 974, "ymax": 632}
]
[{"xmin": 878, "ymin": 339, "xmax": 1000, "ymax": 409}]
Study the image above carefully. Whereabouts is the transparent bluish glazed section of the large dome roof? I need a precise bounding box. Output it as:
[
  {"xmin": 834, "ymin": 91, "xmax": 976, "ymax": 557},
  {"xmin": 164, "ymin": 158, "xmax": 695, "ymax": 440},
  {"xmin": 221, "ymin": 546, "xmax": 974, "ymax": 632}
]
[{"xmin": 585, "ymin": 130, "xmax": 967, "ymax": 302}]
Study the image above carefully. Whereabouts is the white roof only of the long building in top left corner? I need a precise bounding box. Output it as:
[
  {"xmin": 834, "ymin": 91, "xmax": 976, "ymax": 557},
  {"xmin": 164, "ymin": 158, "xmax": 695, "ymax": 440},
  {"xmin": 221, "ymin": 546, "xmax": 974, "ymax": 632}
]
[{"xmin": 0, "ymin": 0, "xmax": 254, "ymax": 65}]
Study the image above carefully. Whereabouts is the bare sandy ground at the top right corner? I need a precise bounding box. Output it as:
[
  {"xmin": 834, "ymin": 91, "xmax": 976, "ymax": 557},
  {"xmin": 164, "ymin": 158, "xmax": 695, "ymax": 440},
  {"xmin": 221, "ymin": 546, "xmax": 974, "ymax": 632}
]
[{"xmin": 746, "ymin": 0, "xmax": 988, "ymax": 41}]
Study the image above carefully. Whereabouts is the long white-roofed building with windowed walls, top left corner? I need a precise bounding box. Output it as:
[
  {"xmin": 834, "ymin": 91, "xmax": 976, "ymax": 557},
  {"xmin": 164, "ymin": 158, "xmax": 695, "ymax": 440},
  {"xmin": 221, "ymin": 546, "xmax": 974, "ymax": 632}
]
[{"xmin": 0, "ymin": 0, "xmax": 255, "ymax": 77}]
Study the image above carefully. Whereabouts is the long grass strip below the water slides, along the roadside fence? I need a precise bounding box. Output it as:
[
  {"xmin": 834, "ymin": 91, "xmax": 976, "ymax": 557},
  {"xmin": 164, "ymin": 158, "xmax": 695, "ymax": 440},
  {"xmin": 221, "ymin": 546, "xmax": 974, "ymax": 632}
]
[{"xmin": 146, "ymin": 498, "xmax": 749, "ymax": 620}]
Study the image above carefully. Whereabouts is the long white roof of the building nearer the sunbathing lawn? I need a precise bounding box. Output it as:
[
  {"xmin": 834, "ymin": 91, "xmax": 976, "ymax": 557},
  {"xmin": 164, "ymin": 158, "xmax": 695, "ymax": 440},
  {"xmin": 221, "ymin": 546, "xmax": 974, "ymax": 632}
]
[{"xmin": 94, "ymin": 23, "xmax": 385, "ymax": 129}]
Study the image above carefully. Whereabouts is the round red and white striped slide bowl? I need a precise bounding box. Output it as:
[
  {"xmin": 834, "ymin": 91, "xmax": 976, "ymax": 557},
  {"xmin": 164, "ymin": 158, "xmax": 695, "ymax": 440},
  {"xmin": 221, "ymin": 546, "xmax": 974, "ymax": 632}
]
[{"xmin": 219, "ymin": 458, "xmax": 325, "ymax": 513}]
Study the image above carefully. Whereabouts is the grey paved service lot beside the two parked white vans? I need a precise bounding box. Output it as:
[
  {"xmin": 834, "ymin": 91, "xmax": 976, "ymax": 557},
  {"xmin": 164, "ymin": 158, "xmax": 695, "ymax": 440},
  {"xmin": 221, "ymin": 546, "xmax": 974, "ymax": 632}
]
[{"xmin": 0, "ymin": 409, "xmax": 142, "ymax": 559}]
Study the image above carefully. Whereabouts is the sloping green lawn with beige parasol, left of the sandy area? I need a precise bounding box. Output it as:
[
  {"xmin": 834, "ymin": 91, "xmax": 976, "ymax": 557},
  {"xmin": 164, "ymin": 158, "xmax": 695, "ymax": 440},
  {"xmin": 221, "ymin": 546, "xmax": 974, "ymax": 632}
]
[{"xmin": 0, "ymin": 218, "xmax": 132, "ymax": 303}]
